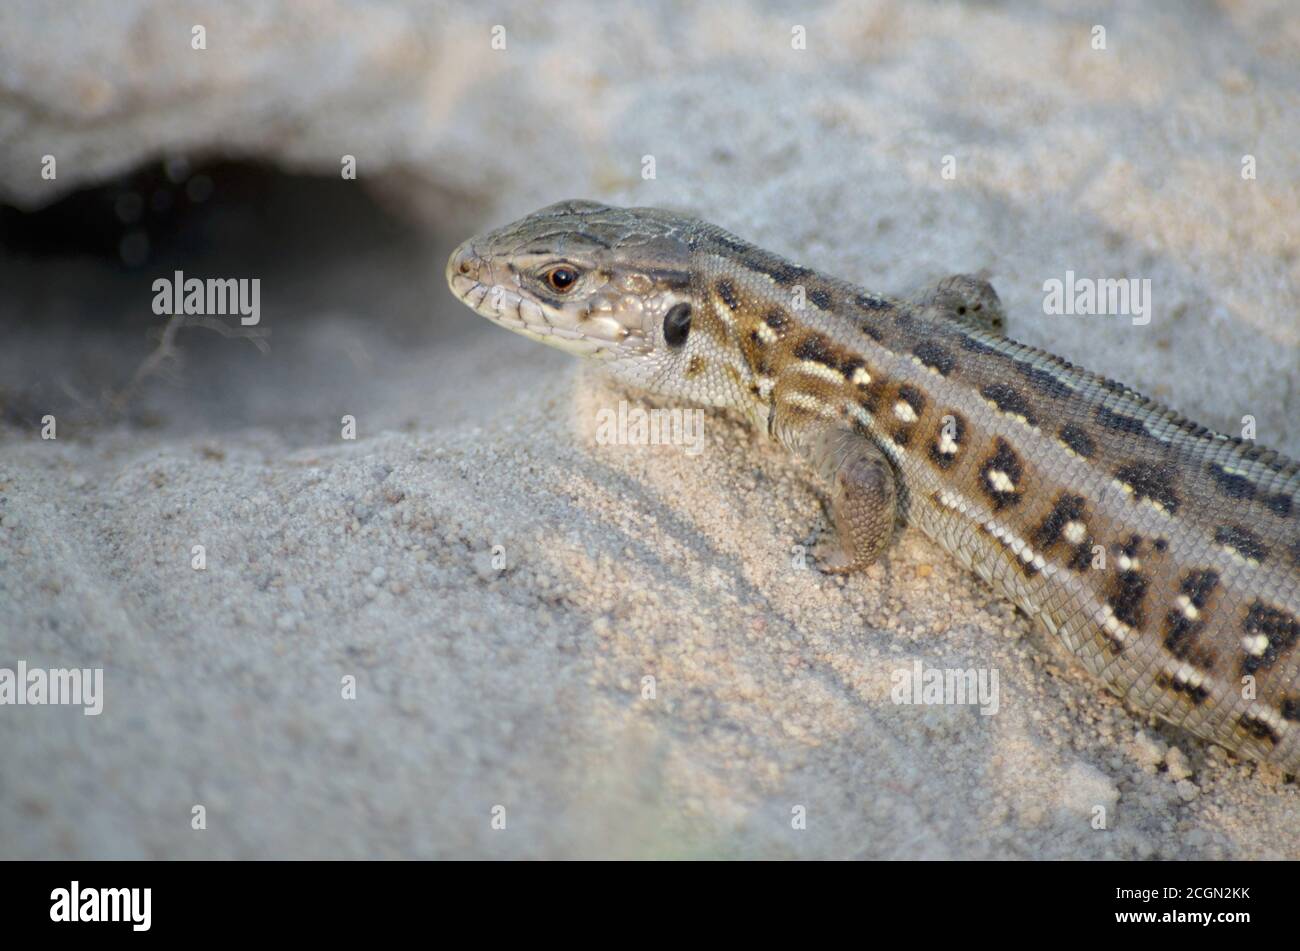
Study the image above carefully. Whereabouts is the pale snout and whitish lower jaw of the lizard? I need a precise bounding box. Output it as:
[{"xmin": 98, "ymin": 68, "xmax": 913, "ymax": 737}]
[{"xmin": 447, "ymin": 242, "xmax": 644, "ymax": 359}]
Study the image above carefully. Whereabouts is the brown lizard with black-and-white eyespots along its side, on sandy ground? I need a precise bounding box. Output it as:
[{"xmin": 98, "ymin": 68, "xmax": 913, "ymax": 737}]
[{"xmin": 446, "ymin": 200, "xmax": 1300, "ymax": 774}]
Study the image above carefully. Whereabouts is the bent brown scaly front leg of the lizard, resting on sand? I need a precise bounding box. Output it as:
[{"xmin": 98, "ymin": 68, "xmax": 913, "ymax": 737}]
[{"xmin": 813, "ymin": 426, "xmax": 897, "ymax": 574}]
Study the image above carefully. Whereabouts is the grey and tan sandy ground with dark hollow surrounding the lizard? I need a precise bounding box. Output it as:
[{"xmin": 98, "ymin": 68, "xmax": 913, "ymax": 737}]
[{"xmin": 0, "ymin": 0, "xmax": 1300, "ymax": 857}]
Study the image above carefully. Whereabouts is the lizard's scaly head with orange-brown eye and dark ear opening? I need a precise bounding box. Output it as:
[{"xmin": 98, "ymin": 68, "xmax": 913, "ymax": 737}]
[{"xmin": 447, "ymin": 201, "xmax": 738, "ymax": 401}]
